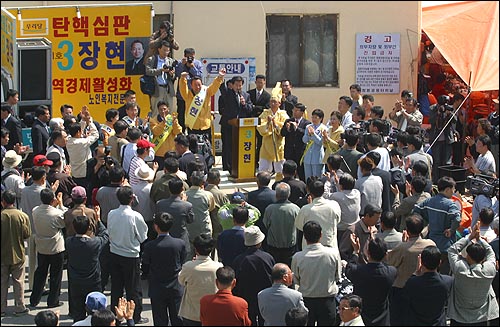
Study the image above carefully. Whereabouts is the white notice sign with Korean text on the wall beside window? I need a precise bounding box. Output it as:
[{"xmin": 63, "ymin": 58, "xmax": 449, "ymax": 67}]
[{"xmin": 356, "ymin": 33, "xmax": 401, "ymax": 94}]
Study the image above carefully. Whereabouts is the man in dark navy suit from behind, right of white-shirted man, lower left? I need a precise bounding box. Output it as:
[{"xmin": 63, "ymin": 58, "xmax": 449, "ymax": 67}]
[{"xmin": 142, "ymin": 212, "xmax": 187, "ymax": 326}]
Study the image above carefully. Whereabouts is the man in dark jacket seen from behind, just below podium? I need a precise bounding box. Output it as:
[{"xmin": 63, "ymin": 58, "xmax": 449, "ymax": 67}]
[{"xmin": 248, "ymin": 171, "xmax": 276, "ymax": 243}]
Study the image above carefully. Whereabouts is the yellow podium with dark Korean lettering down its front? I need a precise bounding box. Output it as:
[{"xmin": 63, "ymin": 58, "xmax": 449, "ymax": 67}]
[{"xmin": 229, "ymin": 118, "xmax": 259, "ymax": 183}]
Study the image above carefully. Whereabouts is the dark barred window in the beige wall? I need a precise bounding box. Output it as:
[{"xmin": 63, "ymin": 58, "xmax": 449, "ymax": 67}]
[{"xmin": 266, "ymin": 15, "xmax": 338, "ymax": 87}]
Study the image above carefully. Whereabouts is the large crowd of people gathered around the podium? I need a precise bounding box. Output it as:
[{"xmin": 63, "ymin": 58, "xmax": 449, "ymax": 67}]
[{"xmin": 1, "ymin": 19, "xmax": 499, "ymax": 326}]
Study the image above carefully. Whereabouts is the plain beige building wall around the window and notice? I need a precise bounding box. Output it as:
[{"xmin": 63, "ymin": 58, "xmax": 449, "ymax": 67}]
[{"xmin": 2, "ymin": 1, "xmax": 421, "ymax": 115}]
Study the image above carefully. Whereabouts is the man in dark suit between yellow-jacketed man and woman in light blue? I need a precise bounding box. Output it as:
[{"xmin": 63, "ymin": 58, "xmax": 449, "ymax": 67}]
[{"xmin": 281, "ymin": 103, "xmax": 311, "ymax": 182}]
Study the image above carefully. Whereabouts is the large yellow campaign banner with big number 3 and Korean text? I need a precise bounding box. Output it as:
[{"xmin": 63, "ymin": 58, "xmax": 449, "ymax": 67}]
[{"xmin": 9, "ymin": 3, "xmax": 152, "ymax": 122}]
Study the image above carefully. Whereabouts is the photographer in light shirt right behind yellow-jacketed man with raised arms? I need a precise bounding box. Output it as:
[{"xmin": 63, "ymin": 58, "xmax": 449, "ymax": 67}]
[{"xmin": 171, "ymin": 48, "xmax": 203, "ymax": 133}]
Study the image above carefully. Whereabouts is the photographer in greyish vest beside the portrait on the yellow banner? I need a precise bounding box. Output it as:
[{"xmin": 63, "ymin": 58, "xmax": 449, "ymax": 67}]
[{"xmin": 146, "ymin": 40, "xmax": 176, "ymax": 117}]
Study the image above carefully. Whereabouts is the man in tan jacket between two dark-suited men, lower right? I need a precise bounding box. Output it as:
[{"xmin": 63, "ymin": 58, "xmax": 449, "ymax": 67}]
[{"xmin": 385, "ymin": 214, "xmax": 440, "ymax": 326}]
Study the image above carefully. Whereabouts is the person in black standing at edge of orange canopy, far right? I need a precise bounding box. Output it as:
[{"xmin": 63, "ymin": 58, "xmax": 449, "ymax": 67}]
[{"xmin": 429, "ymin": 95, "xmax": 457, "ymax": 183}]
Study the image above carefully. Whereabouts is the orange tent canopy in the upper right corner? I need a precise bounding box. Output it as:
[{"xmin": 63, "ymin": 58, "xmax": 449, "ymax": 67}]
[{"xmin": 422, "ymin": 1, "xmax": 499, "ymax": 91}]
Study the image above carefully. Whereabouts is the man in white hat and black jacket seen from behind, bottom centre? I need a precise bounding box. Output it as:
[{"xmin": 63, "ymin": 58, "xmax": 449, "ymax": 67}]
[{"xmin": 233, "ymin": 226, "xmax": 275, "ymax": 326}]
